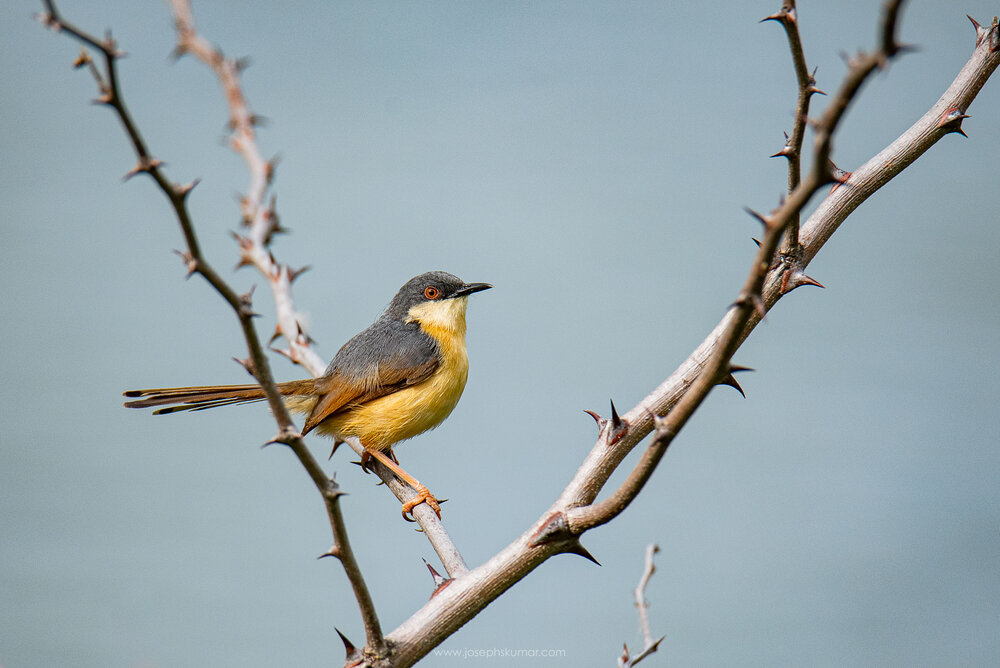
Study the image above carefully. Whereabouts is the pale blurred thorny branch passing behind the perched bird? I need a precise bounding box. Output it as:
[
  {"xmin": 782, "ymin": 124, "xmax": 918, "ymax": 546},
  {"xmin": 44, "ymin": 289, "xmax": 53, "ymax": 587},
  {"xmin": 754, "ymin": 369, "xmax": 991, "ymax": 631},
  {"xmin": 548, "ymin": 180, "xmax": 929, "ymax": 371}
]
[{"xmin": 170, "ymin": 0, "xmax": 469, "ymax": 577}]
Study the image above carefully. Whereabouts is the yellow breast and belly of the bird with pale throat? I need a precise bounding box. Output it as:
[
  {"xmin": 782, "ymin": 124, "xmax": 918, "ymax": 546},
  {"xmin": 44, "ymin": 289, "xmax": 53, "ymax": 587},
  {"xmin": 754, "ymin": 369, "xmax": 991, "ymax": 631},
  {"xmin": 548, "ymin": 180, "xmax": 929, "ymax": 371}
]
[{"xmin": 316, "ymin": 297, "xmax": 469, "ymax": 450}]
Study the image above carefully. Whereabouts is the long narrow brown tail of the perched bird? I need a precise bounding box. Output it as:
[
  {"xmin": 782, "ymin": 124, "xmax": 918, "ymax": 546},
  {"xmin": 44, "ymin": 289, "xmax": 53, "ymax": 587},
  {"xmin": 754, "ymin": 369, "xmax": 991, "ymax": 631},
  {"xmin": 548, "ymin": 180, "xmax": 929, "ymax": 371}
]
[{"xmin": 122, "ymin": 378, "xmax": 316, "ymax": 415}]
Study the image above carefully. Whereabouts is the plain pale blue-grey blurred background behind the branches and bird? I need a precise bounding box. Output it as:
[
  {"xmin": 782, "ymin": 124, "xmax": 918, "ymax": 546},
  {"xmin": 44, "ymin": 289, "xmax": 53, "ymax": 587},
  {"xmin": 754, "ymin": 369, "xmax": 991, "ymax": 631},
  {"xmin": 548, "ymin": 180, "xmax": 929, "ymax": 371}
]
[{"xmin": 0, "ymin": 0, "xmax": 1000, "ymax": 668}]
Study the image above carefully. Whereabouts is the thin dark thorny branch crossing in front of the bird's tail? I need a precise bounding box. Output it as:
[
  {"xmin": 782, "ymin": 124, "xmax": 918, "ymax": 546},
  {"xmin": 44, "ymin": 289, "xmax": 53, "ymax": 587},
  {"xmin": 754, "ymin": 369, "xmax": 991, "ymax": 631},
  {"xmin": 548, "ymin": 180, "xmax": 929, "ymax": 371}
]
[{"xmin": 39, "ymin": 0, "xmax": 386, "ymax": 656}]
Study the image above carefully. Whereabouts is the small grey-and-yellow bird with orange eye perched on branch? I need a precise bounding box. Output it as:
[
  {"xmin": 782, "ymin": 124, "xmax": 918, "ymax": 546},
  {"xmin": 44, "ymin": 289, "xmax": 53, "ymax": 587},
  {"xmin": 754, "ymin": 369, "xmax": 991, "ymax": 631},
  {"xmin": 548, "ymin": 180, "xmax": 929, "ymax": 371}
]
[{"xmin": 123, "ymin": 271, "xmax": 493, "ymax": 521}]
